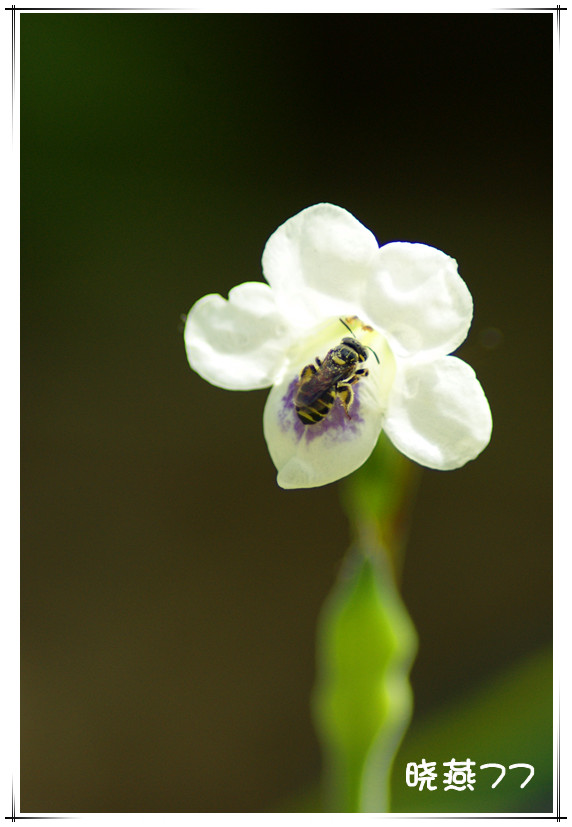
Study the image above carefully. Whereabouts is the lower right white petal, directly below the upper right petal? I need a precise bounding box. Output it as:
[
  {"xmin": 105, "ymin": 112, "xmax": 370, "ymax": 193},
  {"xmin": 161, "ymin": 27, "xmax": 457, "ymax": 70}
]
[{"xmin": 383, "ymin": 356, "xmax": 492, "ymax": 471}]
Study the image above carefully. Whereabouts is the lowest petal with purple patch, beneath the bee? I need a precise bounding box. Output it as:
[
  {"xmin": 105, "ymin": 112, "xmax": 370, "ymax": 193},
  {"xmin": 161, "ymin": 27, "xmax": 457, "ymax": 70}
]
[{"xmin": 264, "ymin": 340, "xmax": 395, "ymax": 488}]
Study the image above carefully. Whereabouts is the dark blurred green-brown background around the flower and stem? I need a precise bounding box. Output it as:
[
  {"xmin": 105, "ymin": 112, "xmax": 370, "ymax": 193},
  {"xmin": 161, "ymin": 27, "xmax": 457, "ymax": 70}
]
[{"xmin": 20, "ymin": 13, "xmax": 553, "ymax": 812}]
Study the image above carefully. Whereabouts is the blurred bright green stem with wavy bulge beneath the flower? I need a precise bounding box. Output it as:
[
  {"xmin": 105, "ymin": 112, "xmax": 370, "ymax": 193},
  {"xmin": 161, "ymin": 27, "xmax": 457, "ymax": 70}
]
[{"xmin": 314, "ymin": 442, "xmax": 417, "ymax": 812}]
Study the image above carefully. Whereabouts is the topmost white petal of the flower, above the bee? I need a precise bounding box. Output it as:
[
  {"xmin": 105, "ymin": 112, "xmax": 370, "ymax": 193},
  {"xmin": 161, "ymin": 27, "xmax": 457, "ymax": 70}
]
[{"xmin": 262, "ymin": 204, "xmax": 379, "ymax": 326}]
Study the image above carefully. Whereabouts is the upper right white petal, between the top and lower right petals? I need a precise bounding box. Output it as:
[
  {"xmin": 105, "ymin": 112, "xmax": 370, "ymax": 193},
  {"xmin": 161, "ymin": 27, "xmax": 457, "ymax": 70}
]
[{"xmin": 365, "ymin": 242, "xmax": 473, "ymax": 356}]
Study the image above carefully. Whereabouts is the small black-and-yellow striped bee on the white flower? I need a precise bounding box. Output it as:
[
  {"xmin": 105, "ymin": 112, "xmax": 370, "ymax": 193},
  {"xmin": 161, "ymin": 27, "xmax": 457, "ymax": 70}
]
[{"xmin": 294, "ymin": 319, "xmax": 379, "ymax": 425}]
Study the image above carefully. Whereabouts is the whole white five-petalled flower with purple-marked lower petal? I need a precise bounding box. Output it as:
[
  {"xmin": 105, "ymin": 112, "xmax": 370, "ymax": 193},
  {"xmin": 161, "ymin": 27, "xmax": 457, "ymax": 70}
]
[{"xmin": 185, "ymin": 204, "xmax": 492, "ymax": 488}]
